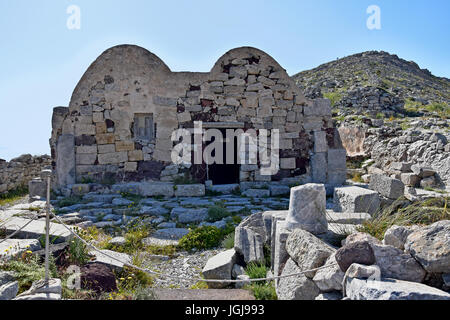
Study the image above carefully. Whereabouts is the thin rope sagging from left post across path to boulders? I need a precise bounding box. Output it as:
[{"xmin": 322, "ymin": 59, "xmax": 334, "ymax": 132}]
[{"xmin": 54, "ymin": 215, "xmax": 337, "ymax": 283}]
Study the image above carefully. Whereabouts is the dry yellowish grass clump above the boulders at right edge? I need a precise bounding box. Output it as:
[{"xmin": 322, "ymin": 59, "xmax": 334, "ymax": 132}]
[{"xmin": 358, "ymin": 197, "xmax": 450, "ymax": 240}]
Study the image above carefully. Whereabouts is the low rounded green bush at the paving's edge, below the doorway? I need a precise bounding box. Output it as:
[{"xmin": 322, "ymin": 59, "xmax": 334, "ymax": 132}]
[{"xmin": 178, "ymin": 226, "xmax": 224, "ymax": 251}]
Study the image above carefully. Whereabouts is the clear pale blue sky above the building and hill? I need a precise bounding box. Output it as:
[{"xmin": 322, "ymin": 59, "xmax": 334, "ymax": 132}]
[{"xmin": 0, "ymin": 0, "xmax": 450, "ymax": 160}]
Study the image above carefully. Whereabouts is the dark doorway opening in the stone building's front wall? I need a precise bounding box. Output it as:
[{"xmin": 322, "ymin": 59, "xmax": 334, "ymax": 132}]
[{"xmin": 208, "ymin": 129, "xmax": 239, "ymax": 185}]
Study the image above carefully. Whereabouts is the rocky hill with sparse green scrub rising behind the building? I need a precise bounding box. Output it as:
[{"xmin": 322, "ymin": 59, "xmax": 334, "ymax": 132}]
[{"xmin": 293, "ymin": 51, "xmax": 450, "ymax": 118}]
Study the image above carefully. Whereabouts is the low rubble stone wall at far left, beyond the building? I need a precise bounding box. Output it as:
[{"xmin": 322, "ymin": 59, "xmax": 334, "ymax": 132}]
[{"xmin": 0, "ymin": 154, "xmax": 51, "ymax": 194}]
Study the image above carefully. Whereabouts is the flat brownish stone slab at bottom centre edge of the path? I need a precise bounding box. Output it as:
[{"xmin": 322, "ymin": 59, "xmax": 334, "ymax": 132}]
[{"xmin": 153, "ymin": 288, "xmax": 255, "ymax": 300}]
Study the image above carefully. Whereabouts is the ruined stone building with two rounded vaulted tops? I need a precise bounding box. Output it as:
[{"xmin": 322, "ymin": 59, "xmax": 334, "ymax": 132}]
[{"xmin": 50, "ymin": 45, "xmax": 346, "ymax": 187}]
